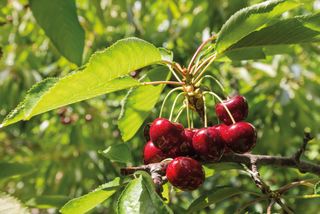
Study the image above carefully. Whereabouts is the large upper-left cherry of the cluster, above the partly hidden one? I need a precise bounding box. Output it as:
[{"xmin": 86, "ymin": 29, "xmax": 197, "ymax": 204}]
[{"xmin": 149, "ymin": 118, "xmax": 183, "ymax": 152}]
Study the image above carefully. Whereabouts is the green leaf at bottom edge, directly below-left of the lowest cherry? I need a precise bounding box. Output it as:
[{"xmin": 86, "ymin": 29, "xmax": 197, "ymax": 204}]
[{"xmin": 117, "ymin": 172, "xmax": 173, "ymax": 214}]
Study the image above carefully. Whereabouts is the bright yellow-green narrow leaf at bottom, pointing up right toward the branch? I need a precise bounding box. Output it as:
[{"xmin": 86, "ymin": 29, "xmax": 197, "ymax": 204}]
[{"xmin": 60, "ymin": 178, "xmax": 120, "ymax": 214}]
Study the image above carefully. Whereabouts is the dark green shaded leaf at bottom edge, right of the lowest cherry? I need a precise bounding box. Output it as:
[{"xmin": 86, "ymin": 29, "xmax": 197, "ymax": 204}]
[{"xmin": 188, "ymin": 187, "xmax": 243, "ymax": 213}]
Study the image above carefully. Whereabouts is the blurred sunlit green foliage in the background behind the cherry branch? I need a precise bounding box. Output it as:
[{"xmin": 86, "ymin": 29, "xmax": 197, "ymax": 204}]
[{"xmin": 0, "ymin": 0, "xmax": 320, "ymax": 213}]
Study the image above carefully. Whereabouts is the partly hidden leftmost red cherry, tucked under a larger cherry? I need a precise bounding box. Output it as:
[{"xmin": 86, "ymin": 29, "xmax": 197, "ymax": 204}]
[{"xmin": 143, "ymin": 141, "xmax": 167, "ymax": 164}]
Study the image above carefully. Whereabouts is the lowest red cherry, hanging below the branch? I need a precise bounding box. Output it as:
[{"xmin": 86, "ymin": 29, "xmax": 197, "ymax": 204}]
[{"xmin": 166, "ymin": 157, "xmax": 205, "ymax": 191}]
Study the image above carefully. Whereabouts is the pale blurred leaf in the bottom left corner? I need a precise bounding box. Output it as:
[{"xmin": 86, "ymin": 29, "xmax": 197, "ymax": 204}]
[{"xmin": 0, "ymin": 193, "xmax": 30, "ymax": 214}]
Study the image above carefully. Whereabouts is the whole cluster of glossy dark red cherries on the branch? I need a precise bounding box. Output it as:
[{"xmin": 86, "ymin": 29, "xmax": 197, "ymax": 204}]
[{"xmin": 144, "ymin": 95, "xmax": 257, "ymax": 191}]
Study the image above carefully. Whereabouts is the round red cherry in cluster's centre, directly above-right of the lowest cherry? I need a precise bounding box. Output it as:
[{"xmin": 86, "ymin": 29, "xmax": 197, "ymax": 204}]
[{"xmin": 192, "ymin": 128, "xmax": 224, "ymax": 161}]
